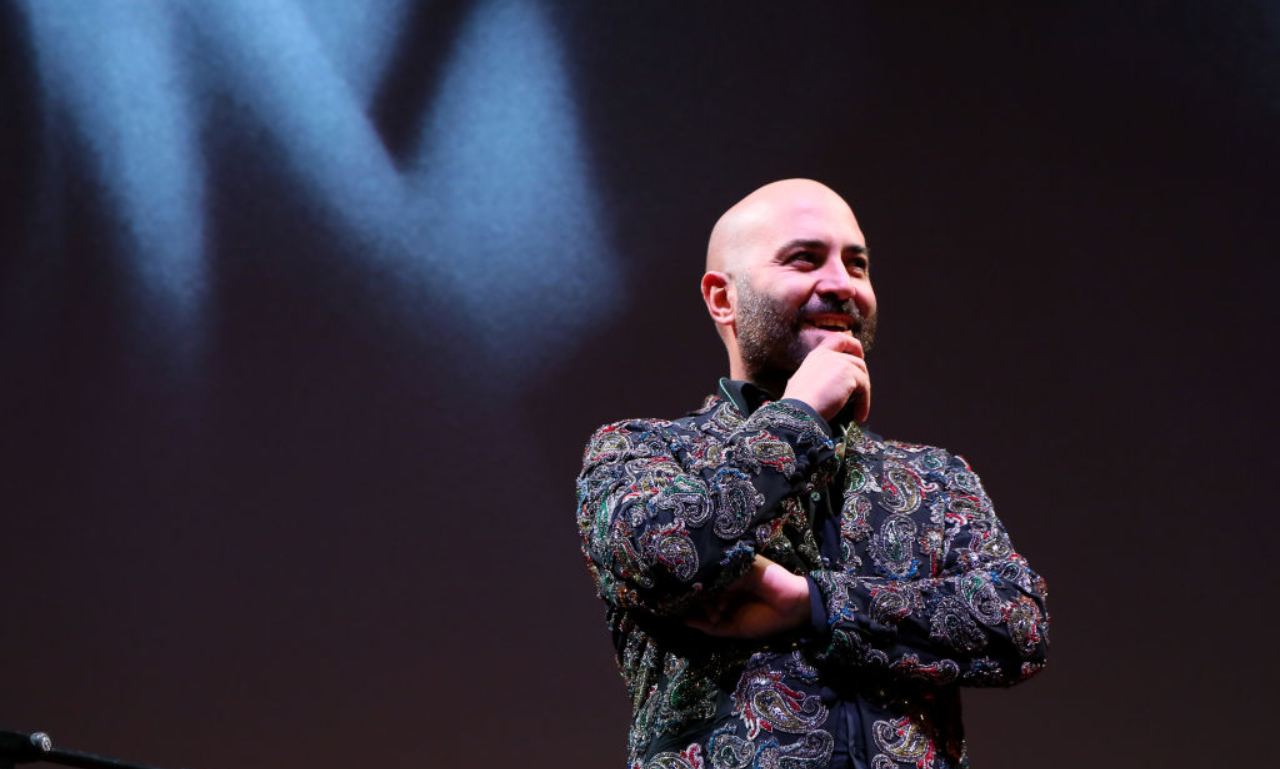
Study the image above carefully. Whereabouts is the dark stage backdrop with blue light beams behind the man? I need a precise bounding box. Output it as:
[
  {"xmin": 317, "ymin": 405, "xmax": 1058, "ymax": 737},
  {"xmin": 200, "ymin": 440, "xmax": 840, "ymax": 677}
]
[{"xmin": 0, "ymin": 0, "xmax": 1280, "ymax": 769}]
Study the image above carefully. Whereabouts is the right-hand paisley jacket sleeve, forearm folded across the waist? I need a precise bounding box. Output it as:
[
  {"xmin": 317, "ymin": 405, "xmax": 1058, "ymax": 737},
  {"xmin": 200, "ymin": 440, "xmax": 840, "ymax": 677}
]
[{"xmin": 809, "ymin": 456, "xmax": 1048, "ymax": 686}]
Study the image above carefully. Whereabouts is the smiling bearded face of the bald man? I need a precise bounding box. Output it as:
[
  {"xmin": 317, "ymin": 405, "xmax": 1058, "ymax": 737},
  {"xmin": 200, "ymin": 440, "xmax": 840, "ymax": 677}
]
[{"xmin": 733, "ymin": 194, "xmax": 876, "ymax": 381}]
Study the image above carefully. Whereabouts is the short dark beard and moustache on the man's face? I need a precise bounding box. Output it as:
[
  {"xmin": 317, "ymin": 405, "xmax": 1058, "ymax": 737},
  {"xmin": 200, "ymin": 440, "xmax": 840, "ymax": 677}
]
[{"xmin": 736, "ymin": 280, "xmax": 877, "ymax": 395}]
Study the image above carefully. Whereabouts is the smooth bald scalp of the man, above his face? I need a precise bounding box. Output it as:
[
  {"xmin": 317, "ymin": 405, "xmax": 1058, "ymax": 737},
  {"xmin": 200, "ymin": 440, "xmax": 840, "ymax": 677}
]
[{"xmin": 707, "ymin": 179, "xmax": 858, "ymax": 275}]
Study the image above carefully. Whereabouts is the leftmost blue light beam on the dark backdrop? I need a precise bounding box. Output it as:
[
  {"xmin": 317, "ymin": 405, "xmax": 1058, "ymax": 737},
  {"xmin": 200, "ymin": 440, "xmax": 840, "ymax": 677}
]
[{"xmin": 24, "ymin": 0, "xmax": 206, "ymax": 352}]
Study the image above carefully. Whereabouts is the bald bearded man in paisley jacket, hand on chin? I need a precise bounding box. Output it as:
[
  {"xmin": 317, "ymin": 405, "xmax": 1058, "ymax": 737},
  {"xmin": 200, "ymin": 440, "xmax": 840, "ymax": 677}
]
[{"xmin": 577, "ymin": 179, "xmax": 1048, "ymax": 769}]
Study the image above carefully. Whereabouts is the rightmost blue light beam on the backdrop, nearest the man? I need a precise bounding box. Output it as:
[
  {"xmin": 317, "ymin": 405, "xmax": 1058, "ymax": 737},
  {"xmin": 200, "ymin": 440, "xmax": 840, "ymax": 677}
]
[{"xmin": 411, "ymin": 0, "xmax": 621, "ymax": 369}]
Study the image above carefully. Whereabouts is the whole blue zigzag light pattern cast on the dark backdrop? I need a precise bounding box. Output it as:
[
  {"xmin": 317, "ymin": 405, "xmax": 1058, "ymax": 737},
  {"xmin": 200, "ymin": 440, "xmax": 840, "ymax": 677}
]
[{"xmin": 16, "ymin": 0, "xmax": 618, "ymax": 381}]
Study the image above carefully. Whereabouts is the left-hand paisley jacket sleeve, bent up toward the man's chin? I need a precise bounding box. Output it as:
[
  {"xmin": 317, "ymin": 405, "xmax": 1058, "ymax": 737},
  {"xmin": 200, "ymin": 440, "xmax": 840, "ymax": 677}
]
[{"xmin": 577, "ymin": 400, "xmax": 835, "ymax": 615}]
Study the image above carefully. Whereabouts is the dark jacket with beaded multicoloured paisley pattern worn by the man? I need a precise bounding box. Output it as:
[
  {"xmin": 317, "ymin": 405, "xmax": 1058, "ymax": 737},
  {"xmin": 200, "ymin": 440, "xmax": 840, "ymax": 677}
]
[{"xmin": 577, "ymin": 395, "xmax": 1048, "ymax": 769}]
